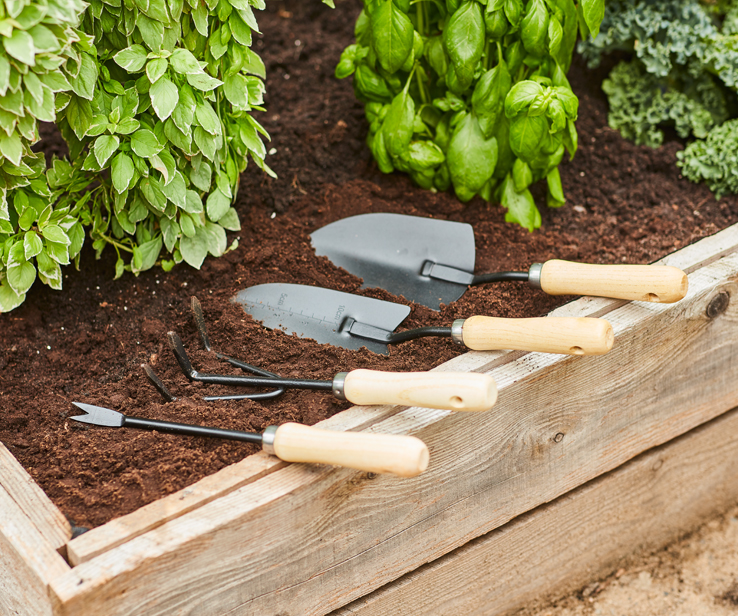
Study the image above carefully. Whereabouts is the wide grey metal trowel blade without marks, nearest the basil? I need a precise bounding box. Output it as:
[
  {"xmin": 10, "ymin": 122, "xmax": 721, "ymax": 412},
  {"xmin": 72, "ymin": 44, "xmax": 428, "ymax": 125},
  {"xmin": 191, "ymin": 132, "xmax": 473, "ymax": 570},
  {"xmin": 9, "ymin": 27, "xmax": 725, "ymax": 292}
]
[{"xmin": 310, "ymin": 214, "xmax": 475, "ymax": 310}]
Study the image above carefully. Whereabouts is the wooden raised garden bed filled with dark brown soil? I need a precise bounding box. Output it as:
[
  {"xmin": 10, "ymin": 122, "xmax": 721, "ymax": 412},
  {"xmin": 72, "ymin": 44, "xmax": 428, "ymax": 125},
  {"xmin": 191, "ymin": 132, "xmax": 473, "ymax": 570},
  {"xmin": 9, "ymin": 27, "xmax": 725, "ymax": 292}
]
[{"xmin": 0, "ymin": 3, "xmax": 738, "ymax": 614}]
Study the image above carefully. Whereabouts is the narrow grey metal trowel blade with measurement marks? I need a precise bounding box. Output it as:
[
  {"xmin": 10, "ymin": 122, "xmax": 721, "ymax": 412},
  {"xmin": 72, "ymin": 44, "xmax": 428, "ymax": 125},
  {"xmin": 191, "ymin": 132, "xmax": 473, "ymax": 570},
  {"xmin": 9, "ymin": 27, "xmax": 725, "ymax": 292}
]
[{"xmin": 232, "ymin": 283, "xmax": 410, "ymax": 355}]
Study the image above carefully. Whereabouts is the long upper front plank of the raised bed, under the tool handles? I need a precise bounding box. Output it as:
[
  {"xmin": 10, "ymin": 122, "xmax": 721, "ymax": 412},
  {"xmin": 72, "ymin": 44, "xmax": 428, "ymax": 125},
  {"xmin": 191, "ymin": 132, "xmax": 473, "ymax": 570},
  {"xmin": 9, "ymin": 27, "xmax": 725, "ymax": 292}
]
[{"xmin": 47, "ymin": 250, "xmax": 738, "ymax": 616}]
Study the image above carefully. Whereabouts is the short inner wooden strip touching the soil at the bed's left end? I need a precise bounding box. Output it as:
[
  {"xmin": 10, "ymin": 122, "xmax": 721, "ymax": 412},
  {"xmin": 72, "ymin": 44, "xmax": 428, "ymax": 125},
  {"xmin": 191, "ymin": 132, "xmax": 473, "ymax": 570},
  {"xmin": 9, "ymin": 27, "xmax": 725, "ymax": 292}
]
[{"xmin": 0, "ymin": 443, "xmax": 72, "ymax": 549}]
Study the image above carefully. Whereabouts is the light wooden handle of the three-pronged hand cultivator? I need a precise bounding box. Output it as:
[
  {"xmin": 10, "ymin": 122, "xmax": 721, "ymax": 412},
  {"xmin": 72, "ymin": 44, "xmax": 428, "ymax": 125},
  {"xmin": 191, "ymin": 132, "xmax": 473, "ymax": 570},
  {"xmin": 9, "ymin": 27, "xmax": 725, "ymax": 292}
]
[{"xmin": 344, "ymin": 370, "xmax": 497, "ymax": 411}]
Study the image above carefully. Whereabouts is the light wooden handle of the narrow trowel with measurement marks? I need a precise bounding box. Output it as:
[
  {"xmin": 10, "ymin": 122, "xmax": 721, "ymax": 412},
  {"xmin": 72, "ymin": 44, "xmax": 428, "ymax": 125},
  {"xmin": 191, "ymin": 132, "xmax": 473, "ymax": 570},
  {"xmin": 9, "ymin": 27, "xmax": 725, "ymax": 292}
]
[{"xmin": 461, "ymin": 317, "xmax": 615, "ymax": 355}]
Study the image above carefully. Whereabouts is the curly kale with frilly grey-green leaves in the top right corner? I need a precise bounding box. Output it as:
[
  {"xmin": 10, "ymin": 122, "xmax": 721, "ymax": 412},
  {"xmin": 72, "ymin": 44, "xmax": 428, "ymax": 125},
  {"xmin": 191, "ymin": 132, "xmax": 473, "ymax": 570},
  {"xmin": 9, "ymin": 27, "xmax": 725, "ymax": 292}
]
[{"xmin": 580, "ymin": 0, "xmax": 738, "ymax": 196}]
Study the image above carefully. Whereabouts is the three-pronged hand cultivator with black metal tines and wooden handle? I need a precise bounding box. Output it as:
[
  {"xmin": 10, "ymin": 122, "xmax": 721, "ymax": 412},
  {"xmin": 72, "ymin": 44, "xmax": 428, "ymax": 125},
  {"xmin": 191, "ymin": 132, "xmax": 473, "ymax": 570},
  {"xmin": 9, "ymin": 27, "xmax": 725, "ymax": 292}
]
[{"xmin": 167, "ymin": 332, "xmax": 497, "ymax": 411}]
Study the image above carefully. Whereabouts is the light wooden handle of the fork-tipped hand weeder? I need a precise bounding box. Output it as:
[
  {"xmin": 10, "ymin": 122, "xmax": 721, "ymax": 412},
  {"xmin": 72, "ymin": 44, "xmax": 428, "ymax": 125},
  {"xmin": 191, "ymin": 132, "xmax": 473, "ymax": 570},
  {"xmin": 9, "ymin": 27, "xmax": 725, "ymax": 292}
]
[{"xmin": 273, "ymin": 423, "xmax": 429, "ymax": 477}]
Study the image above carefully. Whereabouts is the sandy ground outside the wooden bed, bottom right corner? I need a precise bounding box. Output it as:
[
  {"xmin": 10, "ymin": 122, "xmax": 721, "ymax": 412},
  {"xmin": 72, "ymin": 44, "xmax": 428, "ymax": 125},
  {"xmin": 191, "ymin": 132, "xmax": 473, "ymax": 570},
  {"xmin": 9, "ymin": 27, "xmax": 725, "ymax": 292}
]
[{"xmin": 517, "ymin": 507, "xmax": 738, "ymax": 616}]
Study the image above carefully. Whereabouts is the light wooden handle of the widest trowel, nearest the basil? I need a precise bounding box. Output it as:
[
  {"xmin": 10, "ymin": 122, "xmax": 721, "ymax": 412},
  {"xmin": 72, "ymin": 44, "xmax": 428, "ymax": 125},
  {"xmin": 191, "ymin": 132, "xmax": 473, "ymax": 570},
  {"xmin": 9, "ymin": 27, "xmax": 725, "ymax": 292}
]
[{"xmin": 541, "ymin": 259, "xmax": 689, "ymax": 304}]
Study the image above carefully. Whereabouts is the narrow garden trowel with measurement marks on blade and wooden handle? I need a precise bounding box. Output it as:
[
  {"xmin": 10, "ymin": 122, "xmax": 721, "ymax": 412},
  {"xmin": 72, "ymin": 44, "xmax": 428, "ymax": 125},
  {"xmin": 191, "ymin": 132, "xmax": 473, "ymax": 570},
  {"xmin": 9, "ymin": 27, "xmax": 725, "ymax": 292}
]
[{"xmin": 232, "ymin": 283, "xmax": 614, "ymax": 355}]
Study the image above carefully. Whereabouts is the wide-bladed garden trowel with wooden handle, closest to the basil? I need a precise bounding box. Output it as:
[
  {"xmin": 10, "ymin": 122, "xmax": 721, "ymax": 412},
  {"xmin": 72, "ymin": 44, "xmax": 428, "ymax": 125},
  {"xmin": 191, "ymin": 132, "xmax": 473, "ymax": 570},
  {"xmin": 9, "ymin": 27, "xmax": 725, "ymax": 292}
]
[{"xmin": 310, "ymin": 214, "xmax": 687, "ymax": 310}]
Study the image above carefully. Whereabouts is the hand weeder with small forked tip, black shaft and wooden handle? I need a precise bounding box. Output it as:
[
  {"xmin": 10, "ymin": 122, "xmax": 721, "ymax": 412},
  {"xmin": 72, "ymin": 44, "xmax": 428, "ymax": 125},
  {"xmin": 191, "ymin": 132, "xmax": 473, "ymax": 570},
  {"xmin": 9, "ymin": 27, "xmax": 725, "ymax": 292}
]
[{"xmin": 70, "ymin": 402, "xmax": 429, "ymax": 477}]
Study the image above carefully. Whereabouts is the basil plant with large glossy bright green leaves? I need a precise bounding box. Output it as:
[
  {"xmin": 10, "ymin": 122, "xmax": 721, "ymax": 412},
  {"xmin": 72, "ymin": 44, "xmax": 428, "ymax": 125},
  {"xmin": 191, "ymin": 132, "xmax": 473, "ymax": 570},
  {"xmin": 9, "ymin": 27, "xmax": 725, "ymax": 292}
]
[{"xmin": 336, "ymin": 0, "xmax": 604, "ymax": 231}]
